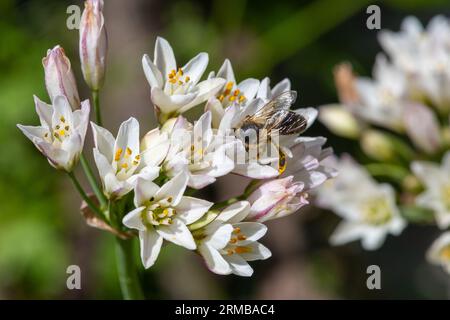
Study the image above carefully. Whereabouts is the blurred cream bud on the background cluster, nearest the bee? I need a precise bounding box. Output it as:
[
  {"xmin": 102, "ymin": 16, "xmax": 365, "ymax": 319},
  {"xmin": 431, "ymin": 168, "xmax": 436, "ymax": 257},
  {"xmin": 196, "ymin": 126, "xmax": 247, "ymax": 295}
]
[{"xmin": 319, "ymin": 105, "xmax": 361, "ymax": 139}]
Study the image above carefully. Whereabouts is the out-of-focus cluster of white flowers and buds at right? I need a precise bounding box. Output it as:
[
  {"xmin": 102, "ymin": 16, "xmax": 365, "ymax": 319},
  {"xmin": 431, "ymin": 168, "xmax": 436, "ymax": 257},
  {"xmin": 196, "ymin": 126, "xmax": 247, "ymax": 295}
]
[{"xmin": 319, "ymin": 16, "xmax": 450, "ymax": 276}]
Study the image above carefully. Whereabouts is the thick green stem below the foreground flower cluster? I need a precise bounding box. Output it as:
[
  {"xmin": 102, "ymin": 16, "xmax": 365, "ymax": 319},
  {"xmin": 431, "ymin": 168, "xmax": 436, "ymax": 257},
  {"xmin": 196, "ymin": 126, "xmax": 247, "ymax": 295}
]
[{"xmin": 116, "ymin": 238, "xmax": 144, "ymax": 300}]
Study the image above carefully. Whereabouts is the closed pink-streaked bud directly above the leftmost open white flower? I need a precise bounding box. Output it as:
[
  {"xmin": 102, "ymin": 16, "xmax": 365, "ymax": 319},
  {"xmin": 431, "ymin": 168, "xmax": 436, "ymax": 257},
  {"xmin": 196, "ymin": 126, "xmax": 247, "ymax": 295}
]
[{"xmin": 42, "ymin": 46, "xmax": 80, "ymax": 109}]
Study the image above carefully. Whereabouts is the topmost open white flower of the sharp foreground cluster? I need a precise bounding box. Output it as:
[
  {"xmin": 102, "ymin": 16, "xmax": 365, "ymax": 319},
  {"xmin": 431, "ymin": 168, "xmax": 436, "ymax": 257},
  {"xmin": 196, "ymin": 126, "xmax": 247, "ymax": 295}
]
[{"xmin": 142, "ymin": 37, "xmax": 225, "ymax": 116}]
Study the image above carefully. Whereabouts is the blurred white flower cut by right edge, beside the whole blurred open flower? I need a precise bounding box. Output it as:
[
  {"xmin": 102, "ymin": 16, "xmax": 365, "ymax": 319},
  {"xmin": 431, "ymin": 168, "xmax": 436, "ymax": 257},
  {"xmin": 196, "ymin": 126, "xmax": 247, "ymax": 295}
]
[{"xmin": 411, "ymin": 152, "xmax": 450, "ymax": 229}]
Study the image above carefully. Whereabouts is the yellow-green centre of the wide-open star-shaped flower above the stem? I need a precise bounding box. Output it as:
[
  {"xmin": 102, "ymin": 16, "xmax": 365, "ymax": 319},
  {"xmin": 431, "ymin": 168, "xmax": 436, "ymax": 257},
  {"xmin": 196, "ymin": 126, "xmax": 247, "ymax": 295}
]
[{"xmin": 142, "ymin": 197, "xmax": 177, "ymax": 226}]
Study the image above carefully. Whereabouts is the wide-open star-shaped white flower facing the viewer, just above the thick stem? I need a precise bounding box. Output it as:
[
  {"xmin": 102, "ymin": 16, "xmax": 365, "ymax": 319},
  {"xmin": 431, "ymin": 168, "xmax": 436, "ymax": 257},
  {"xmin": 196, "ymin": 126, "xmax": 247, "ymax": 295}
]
[{"xmin": 123, "ymin": 173, "xmax": 212, "ymax": 268}]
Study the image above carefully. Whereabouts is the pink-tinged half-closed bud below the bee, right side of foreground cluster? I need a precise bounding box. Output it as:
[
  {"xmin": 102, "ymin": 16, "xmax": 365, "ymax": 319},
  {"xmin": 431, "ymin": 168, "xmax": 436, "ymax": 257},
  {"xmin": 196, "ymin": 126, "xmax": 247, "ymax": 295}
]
[{"xmin": 246, "ymin": 176, "xmax": 308, "ymax": 222}]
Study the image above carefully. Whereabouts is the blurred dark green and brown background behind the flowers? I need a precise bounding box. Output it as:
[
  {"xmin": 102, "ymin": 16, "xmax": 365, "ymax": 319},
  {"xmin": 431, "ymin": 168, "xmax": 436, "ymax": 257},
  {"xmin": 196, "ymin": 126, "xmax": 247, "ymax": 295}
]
[{"xmin": 0, "ymin": 0, "xmax": 450, "ymax": 299}]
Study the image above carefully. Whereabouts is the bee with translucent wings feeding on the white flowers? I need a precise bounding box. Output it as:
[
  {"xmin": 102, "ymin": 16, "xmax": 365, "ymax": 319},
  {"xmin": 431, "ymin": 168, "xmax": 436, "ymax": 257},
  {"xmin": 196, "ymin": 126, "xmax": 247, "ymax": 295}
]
[{"xmin": 238, "ymin": 91, "xmax": 308, "ymax": 174}]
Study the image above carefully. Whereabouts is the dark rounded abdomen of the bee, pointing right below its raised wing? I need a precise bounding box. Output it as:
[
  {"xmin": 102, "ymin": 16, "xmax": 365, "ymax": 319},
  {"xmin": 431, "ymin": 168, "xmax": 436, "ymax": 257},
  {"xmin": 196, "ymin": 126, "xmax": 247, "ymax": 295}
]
[{"xmin": 264, "ymin": 109, "xmax": 307, "ymax": 135}]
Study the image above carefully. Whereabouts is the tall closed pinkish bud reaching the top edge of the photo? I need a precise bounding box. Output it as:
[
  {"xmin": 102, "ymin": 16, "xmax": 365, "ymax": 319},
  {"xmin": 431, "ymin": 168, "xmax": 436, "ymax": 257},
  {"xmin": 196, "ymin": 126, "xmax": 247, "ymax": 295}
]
[{"xmin": 80, "ymin": 0, "xmax": 108, "ymax": 90}]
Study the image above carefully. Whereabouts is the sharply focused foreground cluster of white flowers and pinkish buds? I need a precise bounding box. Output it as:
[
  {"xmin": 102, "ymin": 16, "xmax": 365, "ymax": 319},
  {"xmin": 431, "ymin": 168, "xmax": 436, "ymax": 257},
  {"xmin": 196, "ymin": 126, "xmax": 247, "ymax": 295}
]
[{"xmin": 19, "ymin": 0, "xmax": 335, "ymax": 276}]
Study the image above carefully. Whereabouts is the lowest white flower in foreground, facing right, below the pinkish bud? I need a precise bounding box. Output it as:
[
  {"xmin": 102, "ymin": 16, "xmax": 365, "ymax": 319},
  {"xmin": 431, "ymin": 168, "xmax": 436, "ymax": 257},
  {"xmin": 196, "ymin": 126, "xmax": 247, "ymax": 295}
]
[{"xmin": 196, "ymin": 201, "xmax": 272, "ymax": 277}]
